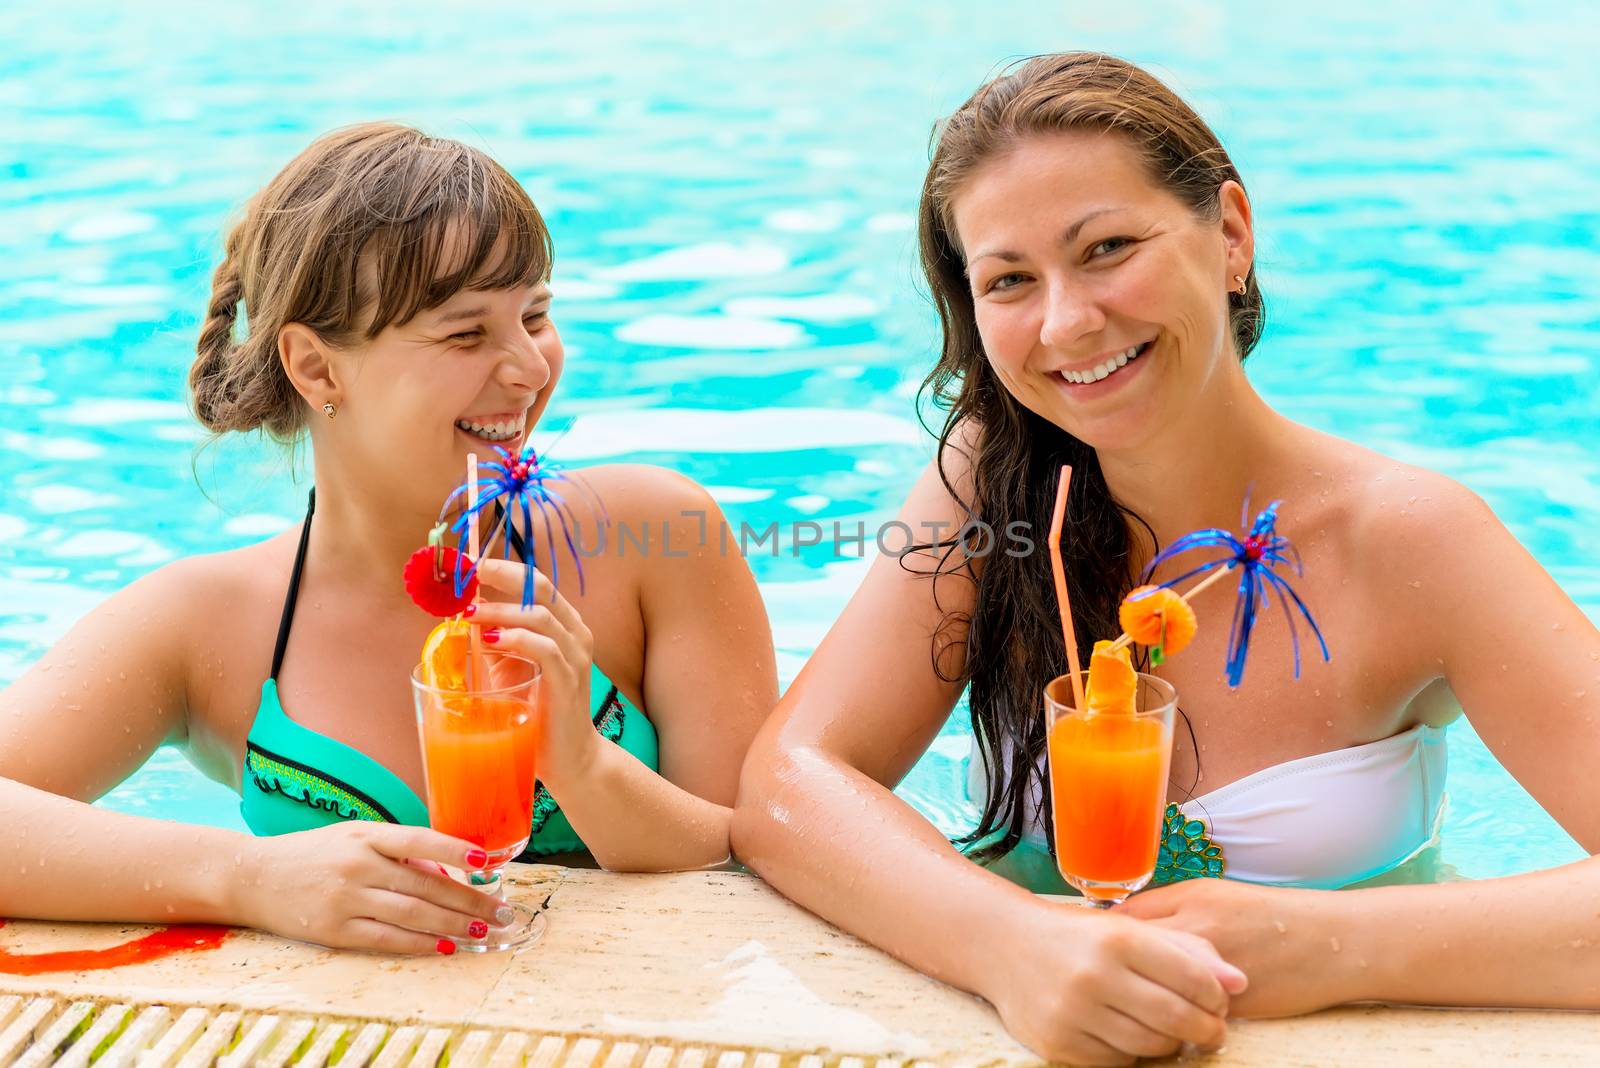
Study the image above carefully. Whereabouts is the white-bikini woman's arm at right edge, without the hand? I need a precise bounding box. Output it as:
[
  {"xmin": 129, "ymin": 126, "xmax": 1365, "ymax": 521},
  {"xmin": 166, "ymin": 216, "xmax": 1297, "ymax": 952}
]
[{"xmin": 1347, "ymin": 475, "xmax": 1600, "ymax": 1009}]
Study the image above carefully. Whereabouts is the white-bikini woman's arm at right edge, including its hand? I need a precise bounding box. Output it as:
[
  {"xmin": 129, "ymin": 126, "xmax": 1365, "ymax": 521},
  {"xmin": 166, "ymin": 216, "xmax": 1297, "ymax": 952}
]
[{"xmin": 1123, "ymin": 473, "xmax": 1600, "ymax": 1015}]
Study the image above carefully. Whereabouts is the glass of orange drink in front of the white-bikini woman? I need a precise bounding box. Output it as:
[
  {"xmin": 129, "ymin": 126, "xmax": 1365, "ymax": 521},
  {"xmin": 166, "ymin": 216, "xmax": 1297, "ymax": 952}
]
[{"xmin": 1045, "ymin": 671, "xmax": 1178, "ymax": 908}]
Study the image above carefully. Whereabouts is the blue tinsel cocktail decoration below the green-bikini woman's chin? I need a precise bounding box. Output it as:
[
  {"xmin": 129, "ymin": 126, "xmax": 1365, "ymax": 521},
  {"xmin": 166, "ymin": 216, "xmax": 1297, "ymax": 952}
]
[{"xmin": 440, "ymin": 441, "xmax": 605, "ymax": 608}]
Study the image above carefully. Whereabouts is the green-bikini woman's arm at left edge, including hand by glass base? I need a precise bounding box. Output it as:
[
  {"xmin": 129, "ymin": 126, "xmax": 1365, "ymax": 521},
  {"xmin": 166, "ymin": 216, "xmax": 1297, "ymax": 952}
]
[{"xmin": 0, "ymin": 560, "xmax": 508, "ymax": 953}]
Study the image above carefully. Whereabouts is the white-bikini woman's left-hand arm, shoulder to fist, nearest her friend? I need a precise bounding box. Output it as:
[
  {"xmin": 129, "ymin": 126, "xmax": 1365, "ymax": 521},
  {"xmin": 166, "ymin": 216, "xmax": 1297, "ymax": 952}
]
[{"xmin": 733, "ymin": 454, "xmax": 1242, "ymax": 1063}]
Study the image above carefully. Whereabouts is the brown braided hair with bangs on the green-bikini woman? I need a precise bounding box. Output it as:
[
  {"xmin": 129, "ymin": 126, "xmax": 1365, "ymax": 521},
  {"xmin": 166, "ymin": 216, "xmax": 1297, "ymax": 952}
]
[{"xmin": 189, "ymin": 123, "xmax": 552, "ymax": 443}]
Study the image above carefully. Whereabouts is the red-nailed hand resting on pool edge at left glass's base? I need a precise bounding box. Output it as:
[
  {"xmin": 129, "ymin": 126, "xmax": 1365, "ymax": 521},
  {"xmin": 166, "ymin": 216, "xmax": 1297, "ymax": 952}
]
[{"xmin": 227, "ymin": 820, "xmax": 501, "ymax": 953}]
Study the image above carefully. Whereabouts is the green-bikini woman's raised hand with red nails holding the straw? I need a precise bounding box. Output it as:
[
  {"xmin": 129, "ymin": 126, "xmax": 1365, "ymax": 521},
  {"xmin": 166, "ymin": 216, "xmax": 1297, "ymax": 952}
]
[{"xmin": 467, "ymin": 560, "xmax": 600, "ymax": 783}]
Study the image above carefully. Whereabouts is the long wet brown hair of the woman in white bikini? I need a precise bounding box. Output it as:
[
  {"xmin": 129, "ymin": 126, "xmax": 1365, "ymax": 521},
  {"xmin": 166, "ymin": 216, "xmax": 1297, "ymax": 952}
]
[{"xmin": 918, "ymin": 53, "xmax": 1264, "ymax": 859}]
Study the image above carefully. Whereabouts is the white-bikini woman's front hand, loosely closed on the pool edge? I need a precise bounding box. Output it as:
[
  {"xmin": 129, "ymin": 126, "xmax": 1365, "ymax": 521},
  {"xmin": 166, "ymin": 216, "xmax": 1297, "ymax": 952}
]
[{"xmin": 984, "ymin": 902, "xmax": 1245, "ymax": 1065}]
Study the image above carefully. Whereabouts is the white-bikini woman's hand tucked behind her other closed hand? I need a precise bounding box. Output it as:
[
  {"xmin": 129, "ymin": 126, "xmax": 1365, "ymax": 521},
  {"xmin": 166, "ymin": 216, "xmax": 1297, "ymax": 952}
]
[{"xmin": 1117, "ymin": 879, "xmax": 1356, "ymax": 1017}]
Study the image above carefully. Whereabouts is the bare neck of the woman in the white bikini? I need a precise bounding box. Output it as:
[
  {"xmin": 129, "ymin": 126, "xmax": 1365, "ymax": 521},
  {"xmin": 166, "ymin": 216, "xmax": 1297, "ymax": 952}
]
[{"xmin": 1098, "ymin": 365, "xmax": 1291, "ymax": 556}]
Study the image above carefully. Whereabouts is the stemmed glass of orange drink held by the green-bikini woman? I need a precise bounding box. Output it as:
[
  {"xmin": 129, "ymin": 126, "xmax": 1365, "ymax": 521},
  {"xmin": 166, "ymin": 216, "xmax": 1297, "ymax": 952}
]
[{"xmin": 411, "ymin": 649, "xmax": 547, "ymax": 953}]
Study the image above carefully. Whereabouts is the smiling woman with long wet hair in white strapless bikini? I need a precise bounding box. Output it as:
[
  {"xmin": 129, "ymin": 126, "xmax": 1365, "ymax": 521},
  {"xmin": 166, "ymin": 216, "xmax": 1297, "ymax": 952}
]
[{"xmin": 733, "ymin": 53, "xmax": 1600, "ymax": 1063}]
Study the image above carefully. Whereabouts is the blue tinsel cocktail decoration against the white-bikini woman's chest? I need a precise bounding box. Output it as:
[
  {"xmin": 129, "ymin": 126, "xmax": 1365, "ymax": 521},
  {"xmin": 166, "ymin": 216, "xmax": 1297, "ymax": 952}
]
[{"xmin": 1144, "ymin": 500, "xmax": 1330, "ymax": 687}]
